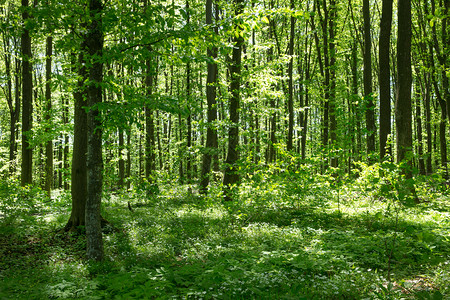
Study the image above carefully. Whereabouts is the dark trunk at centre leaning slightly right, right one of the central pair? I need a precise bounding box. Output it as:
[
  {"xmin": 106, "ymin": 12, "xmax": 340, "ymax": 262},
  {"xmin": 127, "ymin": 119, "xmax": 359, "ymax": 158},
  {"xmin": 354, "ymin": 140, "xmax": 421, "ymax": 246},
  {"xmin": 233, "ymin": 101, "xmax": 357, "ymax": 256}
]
[{"xmin": 223, "ymin": 0, "xmax": 244, "ymax": 201}]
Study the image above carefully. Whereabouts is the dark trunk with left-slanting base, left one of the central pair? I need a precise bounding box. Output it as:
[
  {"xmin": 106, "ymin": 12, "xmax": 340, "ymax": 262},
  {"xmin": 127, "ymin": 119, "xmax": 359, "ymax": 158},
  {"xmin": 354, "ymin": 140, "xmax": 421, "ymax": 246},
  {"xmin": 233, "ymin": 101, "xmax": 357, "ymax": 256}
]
[{"xmin": 200, "ymin": 0, "xmax": 218, "ymax": 193}]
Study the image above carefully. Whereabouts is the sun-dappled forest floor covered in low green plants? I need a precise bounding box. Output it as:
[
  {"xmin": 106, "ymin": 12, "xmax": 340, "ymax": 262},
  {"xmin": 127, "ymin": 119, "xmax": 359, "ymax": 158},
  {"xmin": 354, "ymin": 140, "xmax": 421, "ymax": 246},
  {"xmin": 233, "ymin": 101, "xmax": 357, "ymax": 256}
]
[{"xmin": 0, "ymin": 168, "xmax": 450, "ymax": 299}]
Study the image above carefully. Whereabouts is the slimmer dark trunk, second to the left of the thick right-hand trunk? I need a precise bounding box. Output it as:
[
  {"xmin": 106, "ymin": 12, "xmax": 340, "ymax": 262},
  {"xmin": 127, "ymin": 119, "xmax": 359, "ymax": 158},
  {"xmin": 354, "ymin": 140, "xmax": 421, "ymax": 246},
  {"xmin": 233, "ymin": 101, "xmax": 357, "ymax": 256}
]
[{"xmin": 363, "ymin": 0, "xmax": 376, "ymax": 161}]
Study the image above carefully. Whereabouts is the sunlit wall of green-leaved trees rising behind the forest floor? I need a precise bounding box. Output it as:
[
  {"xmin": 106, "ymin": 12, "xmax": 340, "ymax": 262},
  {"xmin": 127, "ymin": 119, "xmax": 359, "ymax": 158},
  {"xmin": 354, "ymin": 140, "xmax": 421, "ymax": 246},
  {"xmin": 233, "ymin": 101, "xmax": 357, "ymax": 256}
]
[{"xmin": 0, "ymin": 0, "xmax": 449, "ymax": 253}]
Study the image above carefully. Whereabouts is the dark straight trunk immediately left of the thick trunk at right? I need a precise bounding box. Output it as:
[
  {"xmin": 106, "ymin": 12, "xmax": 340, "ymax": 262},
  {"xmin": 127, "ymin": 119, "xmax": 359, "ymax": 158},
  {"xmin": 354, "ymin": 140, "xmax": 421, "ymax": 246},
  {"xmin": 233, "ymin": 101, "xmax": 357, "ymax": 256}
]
[{"xmin": 378, "ymin": 0, "xmax": 392, "ymax": 160}]
